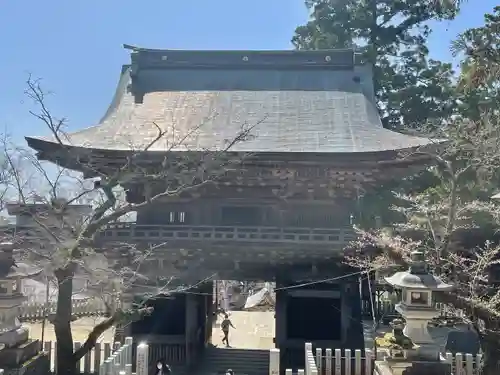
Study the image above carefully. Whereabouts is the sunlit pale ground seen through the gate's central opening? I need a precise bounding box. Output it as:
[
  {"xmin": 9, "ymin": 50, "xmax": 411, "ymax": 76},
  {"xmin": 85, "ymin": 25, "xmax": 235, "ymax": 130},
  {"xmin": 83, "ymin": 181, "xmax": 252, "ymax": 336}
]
[{"xmin": 212, "ymin": 311, "xmax": 275, "ymax": 349}]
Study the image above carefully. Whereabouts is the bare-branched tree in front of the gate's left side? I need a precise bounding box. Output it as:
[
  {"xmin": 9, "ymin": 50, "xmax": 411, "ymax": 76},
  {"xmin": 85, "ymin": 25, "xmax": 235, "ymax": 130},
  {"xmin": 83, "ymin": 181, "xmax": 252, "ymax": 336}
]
[{"xmin": 0, "ymin": 77, "xmax": 252, "ymax": 375}]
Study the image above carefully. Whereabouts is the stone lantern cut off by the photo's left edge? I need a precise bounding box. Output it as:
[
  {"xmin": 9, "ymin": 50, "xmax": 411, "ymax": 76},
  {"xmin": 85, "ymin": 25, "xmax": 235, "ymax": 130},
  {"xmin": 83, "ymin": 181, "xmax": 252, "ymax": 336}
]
[{"xmin": 0, "ymin": 242, "xmax": 49, "ymax": 374}]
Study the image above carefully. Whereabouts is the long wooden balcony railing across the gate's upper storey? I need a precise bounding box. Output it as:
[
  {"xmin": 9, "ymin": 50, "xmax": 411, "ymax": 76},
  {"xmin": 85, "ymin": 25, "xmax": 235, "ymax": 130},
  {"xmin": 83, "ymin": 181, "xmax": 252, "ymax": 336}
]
[{"xmin": 100, "ymin": 223, "xmax": 356, "ymax": 245}]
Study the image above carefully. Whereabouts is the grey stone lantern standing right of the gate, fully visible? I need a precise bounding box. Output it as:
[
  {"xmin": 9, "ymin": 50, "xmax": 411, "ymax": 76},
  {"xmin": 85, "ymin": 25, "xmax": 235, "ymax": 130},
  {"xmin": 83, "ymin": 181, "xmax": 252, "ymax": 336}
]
[{"xmin": 385, "ymin": 251, "xmax": 453, "ymax": 360}]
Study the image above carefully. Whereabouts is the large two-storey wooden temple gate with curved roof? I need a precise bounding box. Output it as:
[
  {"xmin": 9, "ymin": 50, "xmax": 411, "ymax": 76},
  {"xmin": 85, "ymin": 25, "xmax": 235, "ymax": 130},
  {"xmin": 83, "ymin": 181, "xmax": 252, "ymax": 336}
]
[{"xmin": 21, "ymin": 46, "xmax": 429, "ymax": 374}]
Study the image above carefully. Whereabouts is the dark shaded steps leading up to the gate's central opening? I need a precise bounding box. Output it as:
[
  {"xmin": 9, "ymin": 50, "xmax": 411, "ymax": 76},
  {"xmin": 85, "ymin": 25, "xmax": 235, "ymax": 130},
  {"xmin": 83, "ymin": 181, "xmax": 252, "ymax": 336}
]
[{"xmin": 196, "ymin": 347, "xmax": 269, "ymax": 375}]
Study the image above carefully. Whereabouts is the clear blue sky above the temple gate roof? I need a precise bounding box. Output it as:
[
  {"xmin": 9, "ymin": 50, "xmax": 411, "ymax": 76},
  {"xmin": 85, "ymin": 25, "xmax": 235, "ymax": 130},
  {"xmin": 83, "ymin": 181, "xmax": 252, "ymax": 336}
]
[{"xmin": 0, "ymin": 0, "xmax": 497, "ymax": 139}]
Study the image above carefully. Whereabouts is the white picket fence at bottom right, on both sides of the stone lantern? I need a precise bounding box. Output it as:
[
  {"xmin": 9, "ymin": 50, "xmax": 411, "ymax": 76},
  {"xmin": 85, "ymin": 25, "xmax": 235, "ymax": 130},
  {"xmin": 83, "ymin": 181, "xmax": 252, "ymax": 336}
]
[{"xmin": 285, "ymin": 343, "xmax": 482, "ymax": 375}]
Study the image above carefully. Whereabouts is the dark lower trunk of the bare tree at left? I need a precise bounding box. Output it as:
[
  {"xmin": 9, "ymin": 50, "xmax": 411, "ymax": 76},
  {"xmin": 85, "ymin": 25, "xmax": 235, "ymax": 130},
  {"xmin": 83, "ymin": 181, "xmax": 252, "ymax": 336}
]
[{"xmin": 54, "ymin": 265, "xmax": 77, "ymax": 375}]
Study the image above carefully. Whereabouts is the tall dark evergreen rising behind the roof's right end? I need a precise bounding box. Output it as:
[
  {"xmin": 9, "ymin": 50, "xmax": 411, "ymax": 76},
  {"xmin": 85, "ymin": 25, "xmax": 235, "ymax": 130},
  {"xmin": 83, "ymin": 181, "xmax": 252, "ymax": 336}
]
[{"xmin": 292, "ymin": 0, "xmax": 458, "ymax": 129}]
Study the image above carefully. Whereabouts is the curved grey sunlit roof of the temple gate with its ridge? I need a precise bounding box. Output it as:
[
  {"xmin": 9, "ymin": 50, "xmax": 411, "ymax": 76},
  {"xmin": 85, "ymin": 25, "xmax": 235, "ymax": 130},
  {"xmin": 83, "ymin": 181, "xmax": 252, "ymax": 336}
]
[{"xmin": 27, "ymin": 46, "xmax": 430, "ymax": 154}]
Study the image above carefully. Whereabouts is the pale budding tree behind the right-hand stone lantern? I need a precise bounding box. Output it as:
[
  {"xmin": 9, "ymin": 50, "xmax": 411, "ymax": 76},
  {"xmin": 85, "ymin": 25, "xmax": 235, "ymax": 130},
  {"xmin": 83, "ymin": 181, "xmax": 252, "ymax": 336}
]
[{"xmin": 348, "ymin": 114, "xmax": 500, "ymax": 374}]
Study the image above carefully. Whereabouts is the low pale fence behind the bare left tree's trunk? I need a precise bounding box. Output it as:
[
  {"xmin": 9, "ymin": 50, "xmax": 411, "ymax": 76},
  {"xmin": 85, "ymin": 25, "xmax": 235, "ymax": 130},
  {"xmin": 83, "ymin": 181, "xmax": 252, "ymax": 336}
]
[{"xmin": 19, "ymin": 298, "xmax": 106, "ymax": 322}]
